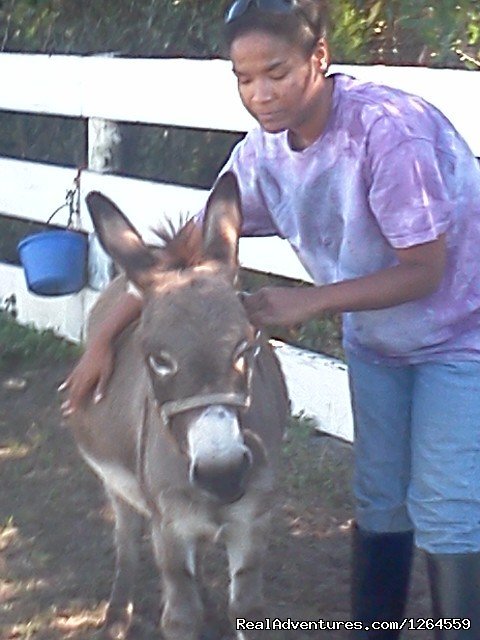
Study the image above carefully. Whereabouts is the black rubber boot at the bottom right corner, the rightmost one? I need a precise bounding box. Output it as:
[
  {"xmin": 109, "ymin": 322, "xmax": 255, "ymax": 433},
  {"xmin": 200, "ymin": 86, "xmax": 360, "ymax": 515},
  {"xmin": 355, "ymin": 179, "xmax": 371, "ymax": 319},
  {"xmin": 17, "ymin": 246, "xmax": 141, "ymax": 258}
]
[{"xmin": 427, "ymin": 553, "xmax": 480, "ymax": 640}]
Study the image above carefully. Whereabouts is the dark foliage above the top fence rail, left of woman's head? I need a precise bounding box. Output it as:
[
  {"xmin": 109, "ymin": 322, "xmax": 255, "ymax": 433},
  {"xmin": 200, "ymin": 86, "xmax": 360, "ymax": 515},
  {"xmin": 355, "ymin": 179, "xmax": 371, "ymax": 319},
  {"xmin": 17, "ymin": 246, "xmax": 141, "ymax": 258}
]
[{"xmin": 0, "ymin": 0, "xmax": 231, "ymax": 57}]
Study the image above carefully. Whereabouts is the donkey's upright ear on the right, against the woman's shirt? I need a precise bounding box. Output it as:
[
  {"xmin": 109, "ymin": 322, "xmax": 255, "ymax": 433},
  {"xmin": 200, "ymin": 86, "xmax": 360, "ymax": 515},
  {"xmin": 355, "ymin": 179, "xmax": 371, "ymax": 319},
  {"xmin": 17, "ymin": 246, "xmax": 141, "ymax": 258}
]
[{"xmin": 203, "ymin": 172, "xmax": 242, "ymax": 269}]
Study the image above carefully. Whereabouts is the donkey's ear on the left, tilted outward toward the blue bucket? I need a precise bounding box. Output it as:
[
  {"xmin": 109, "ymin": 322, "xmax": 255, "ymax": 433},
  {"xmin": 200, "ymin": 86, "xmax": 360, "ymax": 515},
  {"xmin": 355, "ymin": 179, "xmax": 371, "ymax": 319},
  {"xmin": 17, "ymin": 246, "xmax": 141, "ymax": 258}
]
[{"xmin": 86, "ymin": 191, "xmax": 157, "ymax": 288}]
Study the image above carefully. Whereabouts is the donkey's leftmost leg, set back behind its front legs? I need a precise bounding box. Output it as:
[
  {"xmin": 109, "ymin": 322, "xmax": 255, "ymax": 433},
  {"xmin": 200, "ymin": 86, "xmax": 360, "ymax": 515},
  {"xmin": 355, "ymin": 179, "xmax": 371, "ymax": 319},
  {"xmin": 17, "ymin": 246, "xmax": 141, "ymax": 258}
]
[{"xmin": 105, "ymin": 492, "xmax": 143, "ymax": 640}]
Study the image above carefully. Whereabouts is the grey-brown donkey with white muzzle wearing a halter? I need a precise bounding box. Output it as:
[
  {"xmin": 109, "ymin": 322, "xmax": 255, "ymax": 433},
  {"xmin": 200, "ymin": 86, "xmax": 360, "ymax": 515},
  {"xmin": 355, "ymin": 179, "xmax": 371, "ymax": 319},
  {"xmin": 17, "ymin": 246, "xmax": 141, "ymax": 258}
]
[{"xmin": 71, "ymin": 173, "xmax": 289, "ymax": 640}]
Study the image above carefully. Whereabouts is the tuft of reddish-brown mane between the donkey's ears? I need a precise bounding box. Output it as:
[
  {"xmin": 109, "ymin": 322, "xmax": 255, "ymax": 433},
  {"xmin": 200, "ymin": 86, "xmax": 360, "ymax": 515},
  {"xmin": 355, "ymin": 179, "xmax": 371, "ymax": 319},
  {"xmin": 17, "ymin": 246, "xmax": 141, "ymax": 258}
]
[{"xmin": 155, "ymin": 219, "xmax": 203, "ymax": 269}]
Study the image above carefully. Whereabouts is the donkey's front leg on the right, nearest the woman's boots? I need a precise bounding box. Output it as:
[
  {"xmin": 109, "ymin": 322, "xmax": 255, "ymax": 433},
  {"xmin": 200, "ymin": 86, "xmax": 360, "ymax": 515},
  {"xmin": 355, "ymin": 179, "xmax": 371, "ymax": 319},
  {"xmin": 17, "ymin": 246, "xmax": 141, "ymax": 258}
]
[{"xmin": 225, "ymin": 510, "xmax": 270, "ymax": 639}]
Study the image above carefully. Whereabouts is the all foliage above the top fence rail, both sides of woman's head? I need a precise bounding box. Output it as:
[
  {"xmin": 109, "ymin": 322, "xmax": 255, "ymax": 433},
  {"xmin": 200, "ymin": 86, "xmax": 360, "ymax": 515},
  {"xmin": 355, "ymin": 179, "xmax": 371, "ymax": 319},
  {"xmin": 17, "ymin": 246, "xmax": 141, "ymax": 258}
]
[{"xmin": 0, "ymin": 0, "xmax": 480, "ymax": 68}]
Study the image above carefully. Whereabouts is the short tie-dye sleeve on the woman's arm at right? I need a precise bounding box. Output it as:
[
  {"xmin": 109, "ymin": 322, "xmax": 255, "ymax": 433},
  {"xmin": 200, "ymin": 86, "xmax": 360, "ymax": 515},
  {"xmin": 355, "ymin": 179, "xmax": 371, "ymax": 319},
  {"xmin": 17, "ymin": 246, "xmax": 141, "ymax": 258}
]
[{"xmin": 369, "ymin": 119, "xmax": 453, "ymax": 249}]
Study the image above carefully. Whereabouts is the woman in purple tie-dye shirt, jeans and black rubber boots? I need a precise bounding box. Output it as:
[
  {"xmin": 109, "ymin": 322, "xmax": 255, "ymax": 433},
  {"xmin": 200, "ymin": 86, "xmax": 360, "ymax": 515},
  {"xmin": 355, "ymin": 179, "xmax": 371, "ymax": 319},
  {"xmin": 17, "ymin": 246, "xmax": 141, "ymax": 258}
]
[{"xmin": 64, "ymin": 0, "xmax": 480, "ymax": 639}]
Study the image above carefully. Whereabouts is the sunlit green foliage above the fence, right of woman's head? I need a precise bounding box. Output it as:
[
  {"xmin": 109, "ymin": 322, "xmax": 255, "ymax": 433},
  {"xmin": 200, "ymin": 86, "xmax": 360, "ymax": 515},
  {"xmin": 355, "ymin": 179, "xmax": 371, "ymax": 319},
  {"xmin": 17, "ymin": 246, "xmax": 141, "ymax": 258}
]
[{"xmin": 329, "ymin": 0, "xmax": 480, "ymax": 69}]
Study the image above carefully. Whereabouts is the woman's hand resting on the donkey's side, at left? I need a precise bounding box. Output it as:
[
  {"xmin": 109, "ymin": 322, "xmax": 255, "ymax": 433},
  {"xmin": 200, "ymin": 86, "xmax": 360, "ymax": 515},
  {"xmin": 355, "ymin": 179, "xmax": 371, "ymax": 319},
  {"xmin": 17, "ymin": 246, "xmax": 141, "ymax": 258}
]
[{"xmin": 58, "ymin": 343, "xmax": 114, "ymax": 418}]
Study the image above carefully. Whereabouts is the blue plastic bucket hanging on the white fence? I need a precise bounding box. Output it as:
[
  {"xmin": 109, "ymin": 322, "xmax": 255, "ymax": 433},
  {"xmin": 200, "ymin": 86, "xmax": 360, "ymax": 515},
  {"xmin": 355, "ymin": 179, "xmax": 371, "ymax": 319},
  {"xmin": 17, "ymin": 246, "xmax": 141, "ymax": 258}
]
[{"xmin": 18, "ymin": 229, "xmax": 88, "ymax": 296}]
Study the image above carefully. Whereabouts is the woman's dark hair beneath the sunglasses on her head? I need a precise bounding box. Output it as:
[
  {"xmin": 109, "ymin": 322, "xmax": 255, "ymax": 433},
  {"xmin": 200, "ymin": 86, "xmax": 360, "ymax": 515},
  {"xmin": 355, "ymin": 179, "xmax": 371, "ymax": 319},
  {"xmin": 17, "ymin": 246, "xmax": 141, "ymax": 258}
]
[{"xmin": 224, "ymin": 0, "xmax": 326, "ymax": 55}]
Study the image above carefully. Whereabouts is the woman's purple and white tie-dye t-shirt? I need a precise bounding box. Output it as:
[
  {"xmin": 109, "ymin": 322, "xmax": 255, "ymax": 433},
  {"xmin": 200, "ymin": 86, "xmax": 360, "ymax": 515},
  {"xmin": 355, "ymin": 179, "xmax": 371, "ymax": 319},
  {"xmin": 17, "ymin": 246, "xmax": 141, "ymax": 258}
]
[{"xmin": 225, "ymin": 74, "xmax": 480, "ymax": 364}]
